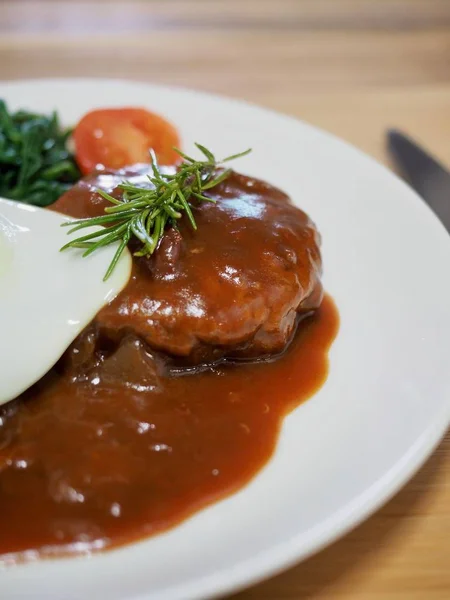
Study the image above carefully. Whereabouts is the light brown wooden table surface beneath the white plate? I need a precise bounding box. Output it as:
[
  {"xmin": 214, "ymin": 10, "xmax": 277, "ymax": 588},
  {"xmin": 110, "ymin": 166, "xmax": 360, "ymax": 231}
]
[{"xmin": 0, "ymin": 0, "xmax": 450, "ymax": 600}]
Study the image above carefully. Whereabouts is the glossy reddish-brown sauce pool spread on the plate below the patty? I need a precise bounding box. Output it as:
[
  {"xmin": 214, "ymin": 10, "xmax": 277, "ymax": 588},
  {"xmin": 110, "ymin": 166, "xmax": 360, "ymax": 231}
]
[{"xmin": 0, "ymin": 296, "xmax": 338, "ymax": 563}]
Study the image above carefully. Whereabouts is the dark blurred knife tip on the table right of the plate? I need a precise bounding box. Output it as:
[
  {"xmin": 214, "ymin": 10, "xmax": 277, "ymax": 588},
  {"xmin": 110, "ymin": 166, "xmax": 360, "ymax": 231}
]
[{"xmin": 387, "ymin": 129, "xmax": 450, "ymax": 232}]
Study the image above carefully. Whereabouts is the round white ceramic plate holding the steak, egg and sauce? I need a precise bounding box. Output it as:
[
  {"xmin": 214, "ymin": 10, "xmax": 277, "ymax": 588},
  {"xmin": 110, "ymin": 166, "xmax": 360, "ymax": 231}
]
[{"xmin": 0, "ymin": 80, "xmax": 450, "ymax": 600}]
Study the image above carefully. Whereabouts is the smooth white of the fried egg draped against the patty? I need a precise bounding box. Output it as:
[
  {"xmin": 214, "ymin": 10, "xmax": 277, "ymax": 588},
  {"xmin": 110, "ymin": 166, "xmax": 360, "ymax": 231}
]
[{"xmin": 0, "ymin": 198, "xmax": 131, "ymax": 404}]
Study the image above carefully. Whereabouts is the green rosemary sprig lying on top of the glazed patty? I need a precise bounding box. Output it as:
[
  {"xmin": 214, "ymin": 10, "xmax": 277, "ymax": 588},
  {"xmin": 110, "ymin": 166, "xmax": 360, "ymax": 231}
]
[{"xmin": 61, "ymin": 144, "xmax": 251, "ymax": 281}]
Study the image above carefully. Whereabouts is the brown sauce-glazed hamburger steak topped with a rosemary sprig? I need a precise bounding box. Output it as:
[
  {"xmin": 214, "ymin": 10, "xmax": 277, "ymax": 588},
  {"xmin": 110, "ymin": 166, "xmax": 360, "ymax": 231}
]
[{"xmin": 52, "ymin": 165, "xmax": 322, "ymax": 364}]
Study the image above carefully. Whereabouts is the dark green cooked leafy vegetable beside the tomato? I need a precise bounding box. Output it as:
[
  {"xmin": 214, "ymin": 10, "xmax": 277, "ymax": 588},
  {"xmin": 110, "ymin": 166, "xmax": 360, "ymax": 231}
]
[{"xmin": 0, "ymin": 100, "xmax": 81, "ymax": 206}]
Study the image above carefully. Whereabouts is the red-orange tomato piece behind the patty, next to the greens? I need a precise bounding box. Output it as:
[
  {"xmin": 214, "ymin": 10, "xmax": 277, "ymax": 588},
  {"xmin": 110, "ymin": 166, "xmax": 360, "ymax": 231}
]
[{"xmin": 73, "ymin": 108, "xmax": 180, "ymax": 174}]
